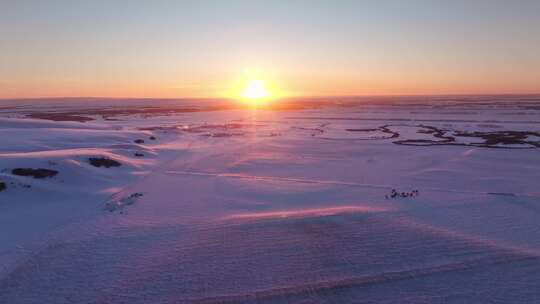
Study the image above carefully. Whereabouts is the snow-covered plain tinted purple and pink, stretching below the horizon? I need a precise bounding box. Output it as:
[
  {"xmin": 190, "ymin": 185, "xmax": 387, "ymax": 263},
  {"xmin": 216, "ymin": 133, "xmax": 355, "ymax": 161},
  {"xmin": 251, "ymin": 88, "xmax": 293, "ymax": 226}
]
[{"xmin": 0, "ymin": 96, "xmax": 540, "ymax": 303}]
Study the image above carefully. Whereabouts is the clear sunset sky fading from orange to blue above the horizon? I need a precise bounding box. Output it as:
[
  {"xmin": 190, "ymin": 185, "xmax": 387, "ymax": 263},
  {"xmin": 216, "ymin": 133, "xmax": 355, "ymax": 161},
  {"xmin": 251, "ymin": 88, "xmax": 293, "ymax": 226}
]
[{"xmin": 0, "ymin": 0, "xmax": 540, "ymax": 98}]
